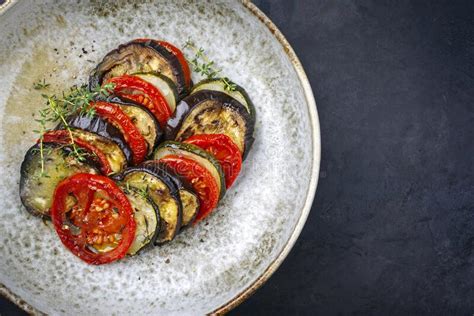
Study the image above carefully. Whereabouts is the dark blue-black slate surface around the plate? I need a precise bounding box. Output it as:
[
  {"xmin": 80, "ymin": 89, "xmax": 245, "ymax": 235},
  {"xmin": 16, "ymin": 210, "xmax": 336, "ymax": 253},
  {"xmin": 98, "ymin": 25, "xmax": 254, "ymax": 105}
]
[{"xmin": 0, "ymin": 0, "xmax": 474, "ymax": 315}]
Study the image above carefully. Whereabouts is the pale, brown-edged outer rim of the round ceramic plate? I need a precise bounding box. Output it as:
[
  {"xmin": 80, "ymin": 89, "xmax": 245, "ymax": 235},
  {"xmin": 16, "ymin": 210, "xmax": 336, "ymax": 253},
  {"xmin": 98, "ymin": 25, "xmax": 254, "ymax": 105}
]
[{"xmin": 0, "ymin": 0, "xmax": 321, "ymax": 315}]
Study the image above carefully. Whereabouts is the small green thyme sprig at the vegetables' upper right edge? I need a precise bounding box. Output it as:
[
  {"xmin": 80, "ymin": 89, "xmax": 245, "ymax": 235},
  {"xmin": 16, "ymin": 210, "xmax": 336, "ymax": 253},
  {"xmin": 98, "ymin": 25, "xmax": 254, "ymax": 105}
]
[{"xmin": 184, "ymin": 40, "xmax": 237, "ymax": 91}]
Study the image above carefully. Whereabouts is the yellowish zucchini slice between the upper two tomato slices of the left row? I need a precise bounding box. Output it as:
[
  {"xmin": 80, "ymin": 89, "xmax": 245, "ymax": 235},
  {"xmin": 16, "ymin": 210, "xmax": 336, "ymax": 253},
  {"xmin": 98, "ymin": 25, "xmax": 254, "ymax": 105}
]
[{"xmin": 107, "ymin": 97, "xmax": 163, "ymax": 155}]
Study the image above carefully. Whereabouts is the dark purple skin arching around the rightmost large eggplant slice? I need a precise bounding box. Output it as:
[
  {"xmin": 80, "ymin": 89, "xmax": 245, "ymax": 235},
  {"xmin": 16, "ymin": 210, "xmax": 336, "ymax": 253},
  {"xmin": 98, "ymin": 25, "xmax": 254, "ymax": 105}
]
[{"xmin": 165, "ymin": 90, "xmax": 255, "ymax": 159}]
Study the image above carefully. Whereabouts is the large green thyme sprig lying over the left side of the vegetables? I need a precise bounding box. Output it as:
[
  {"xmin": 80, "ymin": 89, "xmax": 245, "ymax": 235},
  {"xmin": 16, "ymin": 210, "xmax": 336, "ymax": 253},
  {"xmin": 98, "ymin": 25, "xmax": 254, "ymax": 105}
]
[{"xmin": 34, "ymin": 84, "xmax": 114, "ymax": 176}]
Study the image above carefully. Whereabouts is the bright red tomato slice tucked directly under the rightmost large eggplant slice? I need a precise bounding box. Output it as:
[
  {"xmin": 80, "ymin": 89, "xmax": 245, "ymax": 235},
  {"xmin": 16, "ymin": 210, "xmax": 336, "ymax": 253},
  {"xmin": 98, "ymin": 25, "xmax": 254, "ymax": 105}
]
[{"xmin": 184, "ymin": 134, "xmax": 242, "ymax": 188}]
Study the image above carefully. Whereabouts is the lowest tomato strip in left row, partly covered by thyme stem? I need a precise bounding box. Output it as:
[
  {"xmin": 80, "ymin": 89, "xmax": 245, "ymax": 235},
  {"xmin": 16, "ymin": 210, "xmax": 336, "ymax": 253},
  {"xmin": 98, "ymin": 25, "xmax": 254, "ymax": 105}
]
[{"xmin": 37, "ymin": 130, "xmax": 112, "ymax": 174}]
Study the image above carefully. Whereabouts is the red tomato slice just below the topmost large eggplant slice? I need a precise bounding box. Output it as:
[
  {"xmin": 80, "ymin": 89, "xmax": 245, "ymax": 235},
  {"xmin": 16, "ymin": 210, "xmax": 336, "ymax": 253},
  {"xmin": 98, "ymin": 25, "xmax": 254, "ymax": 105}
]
[{"xmin": 106, "ymin": 75, "xmax": 172, "ymax": 127}]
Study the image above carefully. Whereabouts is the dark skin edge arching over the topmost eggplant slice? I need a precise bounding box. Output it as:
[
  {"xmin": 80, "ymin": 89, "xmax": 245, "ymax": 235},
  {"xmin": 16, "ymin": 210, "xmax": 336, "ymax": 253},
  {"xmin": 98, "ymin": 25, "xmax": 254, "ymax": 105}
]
[{"xmin": 89, "ymin": 40, "xmax": 189, "ymax": 99}]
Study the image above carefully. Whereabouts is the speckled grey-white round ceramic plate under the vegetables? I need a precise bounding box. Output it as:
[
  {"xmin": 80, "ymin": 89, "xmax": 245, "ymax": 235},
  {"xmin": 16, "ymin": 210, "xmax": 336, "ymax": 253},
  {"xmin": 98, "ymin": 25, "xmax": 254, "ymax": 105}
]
[{"xmin": 0, "ymin": 0, "xmax": 320, "ymax": 315}]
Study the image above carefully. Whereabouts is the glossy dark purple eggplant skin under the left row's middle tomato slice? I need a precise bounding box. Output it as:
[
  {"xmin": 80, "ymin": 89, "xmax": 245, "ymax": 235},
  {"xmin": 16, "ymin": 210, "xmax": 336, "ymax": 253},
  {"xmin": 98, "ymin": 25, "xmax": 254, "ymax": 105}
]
[{"xmin": 56, "ymin": 114, "xmax": 133, "ymax": 164}]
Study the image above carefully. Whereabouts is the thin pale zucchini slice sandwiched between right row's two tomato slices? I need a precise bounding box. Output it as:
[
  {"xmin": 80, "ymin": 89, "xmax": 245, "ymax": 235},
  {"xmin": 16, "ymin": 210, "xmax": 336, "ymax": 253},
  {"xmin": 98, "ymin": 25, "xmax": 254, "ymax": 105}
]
[{"xmin": 153, "ymin": 141, "xmax": 226, "ymax": 199}]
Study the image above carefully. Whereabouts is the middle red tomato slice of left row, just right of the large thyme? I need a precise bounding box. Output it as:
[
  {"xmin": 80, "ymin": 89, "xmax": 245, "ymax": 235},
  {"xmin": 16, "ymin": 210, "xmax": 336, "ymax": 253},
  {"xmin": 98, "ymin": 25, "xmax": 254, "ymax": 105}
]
[{"xmin": 91, "ymin": 101, "xmax": 148, "ymax": 164}]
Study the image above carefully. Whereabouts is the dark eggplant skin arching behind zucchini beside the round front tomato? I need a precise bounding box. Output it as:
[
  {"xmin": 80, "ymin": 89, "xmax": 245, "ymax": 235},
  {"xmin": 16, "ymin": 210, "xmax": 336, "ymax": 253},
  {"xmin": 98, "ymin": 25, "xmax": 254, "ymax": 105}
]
[{"xmin": 112, "ymin": 160, "xmax": 183, "ymax": 245}]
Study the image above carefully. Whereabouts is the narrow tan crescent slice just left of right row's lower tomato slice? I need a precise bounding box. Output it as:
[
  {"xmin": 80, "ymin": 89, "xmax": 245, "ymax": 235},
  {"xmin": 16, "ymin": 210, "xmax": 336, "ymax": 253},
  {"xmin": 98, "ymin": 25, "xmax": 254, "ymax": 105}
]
[{"xmin": 156, "ymin": 163, "xmax": 201, "ymax": 229}]
